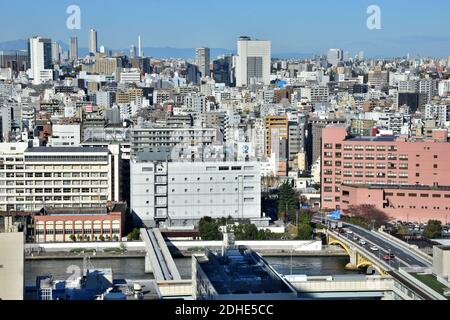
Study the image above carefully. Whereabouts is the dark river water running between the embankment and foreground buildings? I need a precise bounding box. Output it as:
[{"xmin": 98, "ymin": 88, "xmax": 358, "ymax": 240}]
[{"xmin": 25, "ymin": 257, "xmax": 357, "ymax": 285}]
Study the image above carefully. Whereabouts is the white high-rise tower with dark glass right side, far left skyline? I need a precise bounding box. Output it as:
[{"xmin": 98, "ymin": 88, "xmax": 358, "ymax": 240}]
[{"xmin": 28, "ymin": 37, "xmax": 53, "ymax": 84}]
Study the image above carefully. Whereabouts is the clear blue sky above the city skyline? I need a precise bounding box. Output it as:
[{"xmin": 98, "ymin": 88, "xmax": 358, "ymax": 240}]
[{"xmin": 0, "ymin": 0, "xmax": 450, "ymax": 56}]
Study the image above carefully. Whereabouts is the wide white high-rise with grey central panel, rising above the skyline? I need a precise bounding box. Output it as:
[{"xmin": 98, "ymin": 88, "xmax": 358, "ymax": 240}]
[{"xmin": 236, "ymin": 37, "xmax": 272, "ymax": 87}]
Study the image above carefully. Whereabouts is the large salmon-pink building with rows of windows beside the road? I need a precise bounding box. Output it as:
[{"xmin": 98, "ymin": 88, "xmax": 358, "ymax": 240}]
[{"xmin": 322, "ymin": 126, "xmax": 450, "ymax": 223}]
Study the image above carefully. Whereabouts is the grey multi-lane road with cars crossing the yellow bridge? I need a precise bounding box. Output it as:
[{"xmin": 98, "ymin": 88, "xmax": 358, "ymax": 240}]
[{"xmin": 312, "ymin": 219, "xmax": 431, "ymax": 269}]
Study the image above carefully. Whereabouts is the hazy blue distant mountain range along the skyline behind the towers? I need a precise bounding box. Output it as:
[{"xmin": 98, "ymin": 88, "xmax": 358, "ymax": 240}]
[{"xmin": 0, "ymin": 40, "xmax": 314, "ymax": 59}]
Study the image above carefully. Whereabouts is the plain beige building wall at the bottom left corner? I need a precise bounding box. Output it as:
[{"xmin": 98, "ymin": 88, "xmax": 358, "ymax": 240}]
[{"xmin": 0, "ymin": 232, "xmax": 25, "ymax": 300}]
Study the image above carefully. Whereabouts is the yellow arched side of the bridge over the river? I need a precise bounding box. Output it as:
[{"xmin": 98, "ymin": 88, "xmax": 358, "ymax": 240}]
[{"xmin": 326, "ymin": 230, "xmax": 389, "ymax": 276}]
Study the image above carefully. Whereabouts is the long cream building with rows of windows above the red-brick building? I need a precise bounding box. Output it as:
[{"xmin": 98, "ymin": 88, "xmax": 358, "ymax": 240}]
[{"xmin": 0, "ymin": 143, "xmax": 121, "ymax": 212}]
